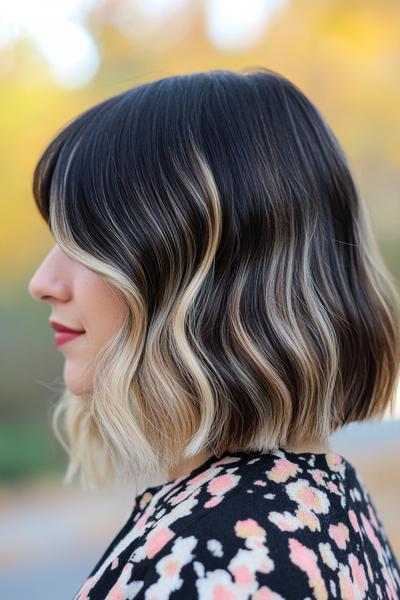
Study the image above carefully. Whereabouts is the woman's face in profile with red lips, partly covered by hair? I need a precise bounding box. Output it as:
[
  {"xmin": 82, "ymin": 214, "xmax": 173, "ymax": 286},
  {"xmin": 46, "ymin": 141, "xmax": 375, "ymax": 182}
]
[{"xmin": 28, "ymin": 244, "xmax": 127, "ymax": 395}]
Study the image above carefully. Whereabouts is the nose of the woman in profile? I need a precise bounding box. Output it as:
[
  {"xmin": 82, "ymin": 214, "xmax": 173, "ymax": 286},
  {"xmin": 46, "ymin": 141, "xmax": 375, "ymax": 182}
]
[{"xmin": 28, "ymin": 247, "xmax": 69, "ymax": 301}]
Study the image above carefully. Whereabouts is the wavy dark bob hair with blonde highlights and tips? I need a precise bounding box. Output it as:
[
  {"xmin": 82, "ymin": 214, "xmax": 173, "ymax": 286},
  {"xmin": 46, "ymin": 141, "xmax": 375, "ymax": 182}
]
[{"xmin": 33, "ymin": 67, "xmax": 400, "ymax": 489}]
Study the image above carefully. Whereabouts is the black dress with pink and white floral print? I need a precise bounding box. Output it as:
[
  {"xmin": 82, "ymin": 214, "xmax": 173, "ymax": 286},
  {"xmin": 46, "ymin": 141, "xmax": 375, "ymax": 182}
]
[{"xmin": 74, "ymin": 449, "xmax": 400, "ymax": 600}]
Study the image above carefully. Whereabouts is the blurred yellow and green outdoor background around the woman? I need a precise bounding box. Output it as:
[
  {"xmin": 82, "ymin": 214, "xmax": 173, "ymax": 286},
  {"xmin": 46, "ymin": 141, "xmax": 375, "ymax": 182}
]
[{"xmin": 0, "ymin": 0, "xmax": 400, "ymax": 600}]
